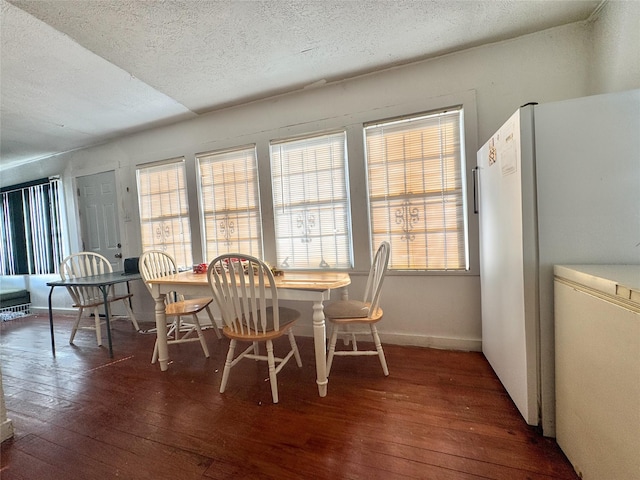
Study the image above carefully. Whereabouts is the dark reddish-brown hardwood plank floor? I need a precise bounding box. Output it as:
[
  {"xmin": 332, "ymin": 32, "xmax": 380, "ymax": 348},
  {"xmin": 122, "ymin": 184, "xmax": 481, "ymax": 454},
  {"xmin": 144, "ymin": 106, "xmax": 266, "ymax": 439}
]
[{"xmin": 0, "ymin": 315, "xmax": 578, "ymax": 480}]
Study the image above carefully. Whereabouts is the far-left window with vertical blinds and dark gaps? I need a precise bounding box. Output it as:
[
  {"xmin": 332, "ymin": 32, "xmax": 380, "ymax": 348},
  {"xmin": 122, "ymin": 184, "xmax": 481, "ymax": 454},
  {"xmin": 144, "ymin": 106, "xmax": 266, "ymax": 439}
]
[{"xmin": 0, "ymin": 177, "xmax": 64, "ymax": 275}]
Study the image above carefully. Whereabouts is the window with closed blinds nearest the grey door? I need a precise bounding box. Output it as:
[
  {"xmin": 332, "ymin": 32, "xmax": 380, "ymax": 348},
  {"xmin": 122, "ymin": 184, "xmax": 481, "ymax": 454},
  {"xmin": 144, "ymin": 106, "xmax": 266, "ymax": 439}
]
[{"xmin": 136, "ymin": 158, "xmax": 193, "ymax": 268}]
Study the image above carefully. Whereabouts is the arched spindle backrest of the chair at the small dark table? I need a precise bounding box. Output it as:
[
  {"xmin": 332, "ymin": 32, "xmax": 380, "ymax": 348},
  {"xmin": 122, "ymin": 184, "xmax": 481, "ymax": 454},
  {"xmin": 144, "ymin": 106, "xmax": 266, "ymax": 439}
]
[{"xmin": 60, "ymin": 252, "xmax": 113, "ymax": 305}]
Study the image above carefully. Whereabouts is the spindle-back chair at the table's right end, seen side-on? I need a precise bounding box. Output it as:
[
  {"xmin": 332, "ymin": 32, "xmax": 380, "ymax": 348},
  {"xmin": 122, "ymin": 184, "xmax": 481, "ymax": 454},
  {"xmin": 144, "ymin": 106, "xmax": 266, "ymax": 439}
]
[{"xmin": 324, "ymin": 242, "xmax": 390, "ymax": 375}]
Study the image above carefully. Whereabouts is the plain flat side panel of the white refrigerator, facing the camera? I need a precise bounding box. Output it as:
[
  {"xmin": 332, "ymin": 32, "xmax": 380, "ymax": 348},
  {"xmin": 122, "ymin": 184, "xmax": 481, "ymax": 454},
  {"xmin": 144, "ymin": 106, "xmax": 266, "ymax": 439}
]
[{"xmin": 535, "ymin": 90, "xmax": 640, "ymax": 435}]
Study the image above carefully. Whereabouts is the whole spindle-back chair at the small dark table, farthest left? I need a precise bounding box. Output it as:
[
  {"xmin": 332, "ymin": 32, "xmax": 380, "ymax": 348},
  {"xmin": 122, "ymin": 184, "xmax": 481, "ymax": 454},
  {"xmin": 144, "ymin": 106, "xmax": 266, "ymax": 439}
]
[{"xmin": 60, "ymin": 252, "xmax": 140, "ymax": 346}]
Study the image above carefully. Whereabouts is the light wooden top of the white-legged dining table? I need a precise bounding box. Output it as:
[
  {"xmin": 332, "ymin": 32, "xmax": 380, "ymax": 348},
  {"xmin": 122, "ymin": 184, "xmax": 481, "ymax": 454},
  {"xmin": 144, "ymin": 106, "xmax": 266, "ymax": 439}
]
[{"xmin": 149, "ymin": 271, "xmax": 351, "ymax": 291}]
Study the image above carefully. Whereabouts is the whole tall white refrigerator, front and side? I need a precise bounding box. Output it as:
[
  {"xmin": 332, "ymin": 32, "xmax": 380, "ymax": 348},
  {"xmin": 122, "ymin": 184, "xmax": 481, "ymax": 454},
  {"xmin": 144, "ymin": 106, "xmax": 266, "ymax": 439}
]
[{"xmin": 474, "ymin": 90, "xmax": 640, "ymax": 436}]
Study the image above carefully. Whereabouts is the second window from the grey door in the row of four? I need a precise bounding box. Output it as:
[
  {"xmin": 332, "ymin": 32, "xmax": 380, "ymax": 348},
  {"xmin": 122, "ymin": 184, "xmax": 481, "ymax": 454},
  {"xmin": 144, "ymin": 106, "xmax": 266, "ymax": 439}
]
[{"xmin": 197, "ymin": 146, "xmax": 262, "ymax": 260}]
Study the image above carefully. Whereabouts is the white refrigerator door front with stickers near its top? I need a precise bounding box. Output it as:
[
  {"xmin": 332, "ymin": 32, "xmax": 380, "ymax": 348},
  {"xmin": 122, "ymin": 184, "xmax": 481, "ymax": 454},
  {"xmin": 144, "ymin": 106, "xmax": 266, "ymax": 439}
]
[{"xmin": 478, "ymin": 111, "xmax": 537, "ymax": 425}]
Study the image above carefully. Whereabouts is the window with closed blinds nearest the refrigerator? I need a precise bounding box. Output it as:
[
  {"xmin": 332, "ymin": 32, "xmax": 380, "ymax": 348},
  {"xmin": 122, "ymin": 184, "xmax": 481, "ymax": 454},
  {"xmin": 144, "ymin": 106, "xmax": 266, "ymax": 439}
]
[{"xmin": 365, "ymin": 108, "xmax": 468, "ymax": 270}]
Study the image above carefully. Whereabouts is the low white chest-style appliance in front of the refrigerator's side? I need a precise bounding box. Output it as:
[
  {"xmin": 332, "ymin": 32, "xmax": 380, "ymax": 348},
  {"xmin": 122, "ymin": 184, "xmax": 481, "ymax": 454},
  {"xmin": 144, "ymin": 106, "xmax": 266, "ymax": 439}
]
[{"xmin": 554, "ymin": 265, "xmax": 640, "ymax": 480}]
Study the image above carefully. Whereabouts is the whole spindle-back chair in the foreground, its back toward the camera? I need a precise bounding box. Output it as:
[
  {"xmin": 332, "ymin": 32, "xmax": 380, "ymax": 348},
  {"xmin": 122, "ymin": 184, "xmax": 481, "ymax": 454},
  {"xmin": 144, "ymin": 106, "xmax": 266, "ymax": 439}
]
[{"xmin": 207, "ymin": 253, "xmax": 302, "ymax": 403}]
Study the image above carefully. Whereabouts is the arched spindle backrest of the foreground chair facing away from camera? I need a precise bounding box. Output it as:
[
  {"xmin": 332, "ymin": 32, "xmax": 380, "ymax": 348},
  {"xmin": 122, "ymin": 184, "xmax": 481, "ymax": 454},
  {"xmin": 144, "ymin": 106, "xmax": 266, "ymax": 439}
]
[{"xmin": 207, "ymin": 253, "xmax": 280, "ymax": 334}]
